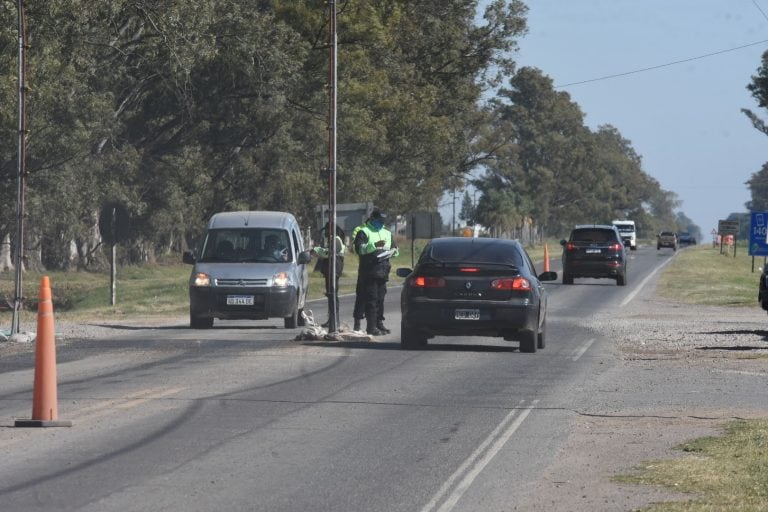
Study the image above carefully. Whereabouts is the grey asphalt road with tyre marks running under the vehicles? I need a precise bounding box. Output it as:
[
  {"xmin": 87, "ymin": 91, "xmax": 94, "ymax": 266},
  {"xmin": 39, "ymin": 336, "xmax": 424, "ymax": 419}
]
[{"xmin": 0, "ymin": 248, "xmax": 764, "ymax": 512}]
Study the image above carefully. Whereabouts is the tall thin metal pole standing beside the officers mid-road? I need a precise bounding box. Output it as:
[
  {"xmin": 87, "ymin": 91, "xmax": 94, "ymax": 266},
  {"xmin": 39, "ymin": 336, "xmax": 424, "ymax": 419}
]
[{"xmin": 326, "ymin": 0, "xmax": 339, "ymax": 333}]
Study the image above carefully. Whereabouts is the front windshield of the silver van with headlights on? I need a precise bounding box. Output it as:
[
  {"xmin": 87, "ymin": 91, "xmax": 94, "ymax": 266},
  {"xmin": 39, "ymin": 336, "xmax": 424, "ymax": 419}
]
[{"xmin": 200, "ymin": 228, "xmax": 293, "ymax": 263}]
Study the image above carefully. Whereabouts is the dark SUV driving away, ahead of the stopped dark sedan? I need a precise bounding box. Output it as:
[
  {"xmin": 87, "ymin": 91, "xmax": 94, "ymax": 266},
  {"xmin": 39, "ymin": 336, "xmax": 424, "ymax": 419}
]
[{"xmin": 560, "ymin": 224, "xmax": 627, "ymax": 286}]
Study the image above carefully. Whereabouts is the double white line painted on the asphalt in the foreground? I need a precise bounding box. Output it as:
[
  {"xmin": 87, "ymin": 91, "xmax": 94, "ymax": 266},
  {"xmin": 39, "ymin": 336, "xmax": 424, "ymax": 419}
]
[{"xmin": 421, "ymin": 400, "xmax": 539, "ymax": 512}]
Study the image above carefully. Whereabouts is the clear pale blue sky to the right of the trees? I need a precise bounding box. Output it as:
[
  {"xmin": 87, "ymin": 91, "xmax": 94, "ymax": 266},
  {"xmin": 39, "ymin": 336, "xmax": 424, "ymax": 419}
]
[{"xmin": 504, "ymin": 0, "xmax": 768, "ymax": 239}]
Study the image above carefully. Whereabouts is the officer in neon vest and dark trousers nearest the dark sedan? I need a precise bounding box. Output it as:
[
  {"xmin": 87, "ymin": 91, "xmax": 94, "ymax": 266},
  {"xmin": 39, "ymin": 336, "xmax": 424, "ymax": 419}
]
[{"xmin": 354, "ymin": 208, "xmax": 399, "ymax": 336}]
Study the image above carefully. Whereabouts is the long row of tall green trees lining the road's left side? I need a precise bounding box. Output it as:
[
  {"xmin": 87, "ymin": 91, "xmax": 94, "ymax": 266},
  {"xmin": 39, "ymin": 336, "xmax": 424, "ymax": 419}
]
[{"xmin": 0, "ymin": 0, "xmax": 688, "ymax": 271}]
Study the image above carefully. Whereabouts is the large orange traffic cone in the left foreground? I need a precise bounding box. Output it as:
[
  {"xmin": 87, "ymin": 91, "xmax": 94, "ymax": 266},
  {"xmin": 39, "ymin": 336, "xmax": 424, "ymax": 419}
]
[{"xmin": 15, "ymin": 276, "xmax": 72, "ymax": 427}]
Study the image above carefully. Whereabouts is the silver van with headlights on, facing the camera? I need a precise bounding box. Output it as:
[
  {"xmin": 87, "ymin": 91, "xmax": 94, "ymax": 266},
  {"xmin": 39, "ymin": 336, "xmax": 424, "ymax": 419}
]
[{"xmin": 183, "ymin": 211, "xmax": 311, "ymax": 329}]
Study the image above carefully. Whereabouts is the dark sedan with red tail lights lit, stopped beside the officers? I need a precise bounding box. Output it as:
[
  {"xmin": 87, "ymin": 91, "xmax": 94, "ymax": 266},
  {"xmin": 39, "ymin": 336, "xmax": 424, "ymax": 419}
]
[{"xmin": 397, "ymin": 237, "xmax": 557, "ymax": 352}]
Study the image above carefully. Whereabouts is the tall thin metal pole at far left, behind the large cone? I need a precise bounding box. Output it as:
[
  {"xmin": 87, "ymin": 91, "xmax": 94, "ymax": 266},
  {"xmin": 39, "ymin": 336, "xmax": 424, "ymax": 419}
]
[{"xmin": 11, "ymin": 0, "xmax": 27, "ymax": 334}]
